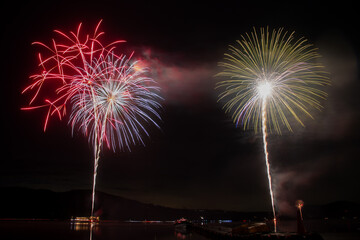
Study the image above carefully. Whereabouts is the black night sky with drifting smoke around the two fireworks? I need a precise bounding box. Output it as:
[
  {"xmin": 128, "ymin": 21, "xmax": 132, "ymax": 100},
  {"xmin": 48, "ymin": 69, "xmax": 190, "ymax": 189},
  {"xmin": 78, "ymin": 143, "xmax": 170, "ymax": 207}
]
[{"xmin": 0, "ymin": 1, "xmax": 360, "ymax": 213}]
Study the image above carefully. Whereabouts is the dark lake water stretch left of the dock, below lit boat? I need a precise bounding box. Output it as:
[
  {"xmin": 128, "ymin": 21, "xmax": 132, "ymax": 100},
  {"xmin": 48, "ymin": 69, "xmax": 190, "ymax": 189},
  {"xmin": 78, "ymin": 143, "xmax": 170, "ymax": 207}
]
[{"xmin": 0, "ymin": 221, "xmax": 206, "ymax": 240}]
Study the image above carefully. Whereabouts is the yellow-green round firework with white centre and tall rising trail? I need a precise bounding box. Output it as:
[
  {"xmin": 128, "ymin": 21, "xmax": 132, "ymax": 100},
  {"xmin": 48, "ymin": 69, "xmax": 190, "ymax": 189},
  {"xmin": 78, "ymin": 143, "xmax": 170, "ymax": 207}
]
[{"xmin": 217, "ymin": 28, "xmax": 330, "ymax": 231}]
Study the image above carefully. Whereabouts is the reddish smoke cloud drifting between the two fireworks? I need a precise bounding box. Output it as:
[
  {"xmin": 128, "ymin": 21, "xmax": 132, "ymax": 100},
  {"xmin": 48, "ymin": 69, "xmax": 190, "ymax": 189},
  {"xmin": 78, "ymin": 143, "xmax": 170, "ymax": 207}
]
[{"xmin": 133, "ymin": 48, "xmax": 216, "ymax": 105}]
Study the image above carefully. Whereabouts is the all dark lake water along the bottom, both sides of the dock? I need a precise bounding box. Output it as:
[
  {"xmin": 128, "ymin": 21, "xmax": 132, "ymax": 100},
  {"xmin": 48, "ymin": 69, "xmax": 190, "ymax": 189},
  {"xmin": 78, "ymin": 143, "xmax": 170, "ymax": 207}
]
[{"xmin": 0, "ymin": 221, "xmax": 360, "ymax": 240}]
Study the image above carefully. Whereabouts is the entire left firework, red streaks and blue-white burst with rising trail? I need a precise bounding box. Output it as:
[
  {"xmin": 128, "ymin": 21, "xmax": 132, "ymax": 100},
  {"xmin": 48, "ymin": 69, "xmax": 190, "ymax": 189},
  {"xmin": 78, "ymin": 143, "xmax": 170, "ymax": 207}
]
[{"xmin": 22, "ymin": 21, "xmax": 161, "ymax": 216}]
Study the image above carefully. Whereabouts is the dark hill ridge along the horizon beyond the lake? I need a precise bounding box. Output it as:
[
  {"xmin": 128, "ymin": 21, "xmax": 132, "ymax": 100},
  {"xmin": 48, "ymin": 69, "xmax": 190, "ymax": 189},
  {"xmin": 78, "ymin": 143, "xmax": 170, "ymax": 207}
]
[{"xmin": 0, "ymin": 188, "xmax": 360, "ymax": 221}]
